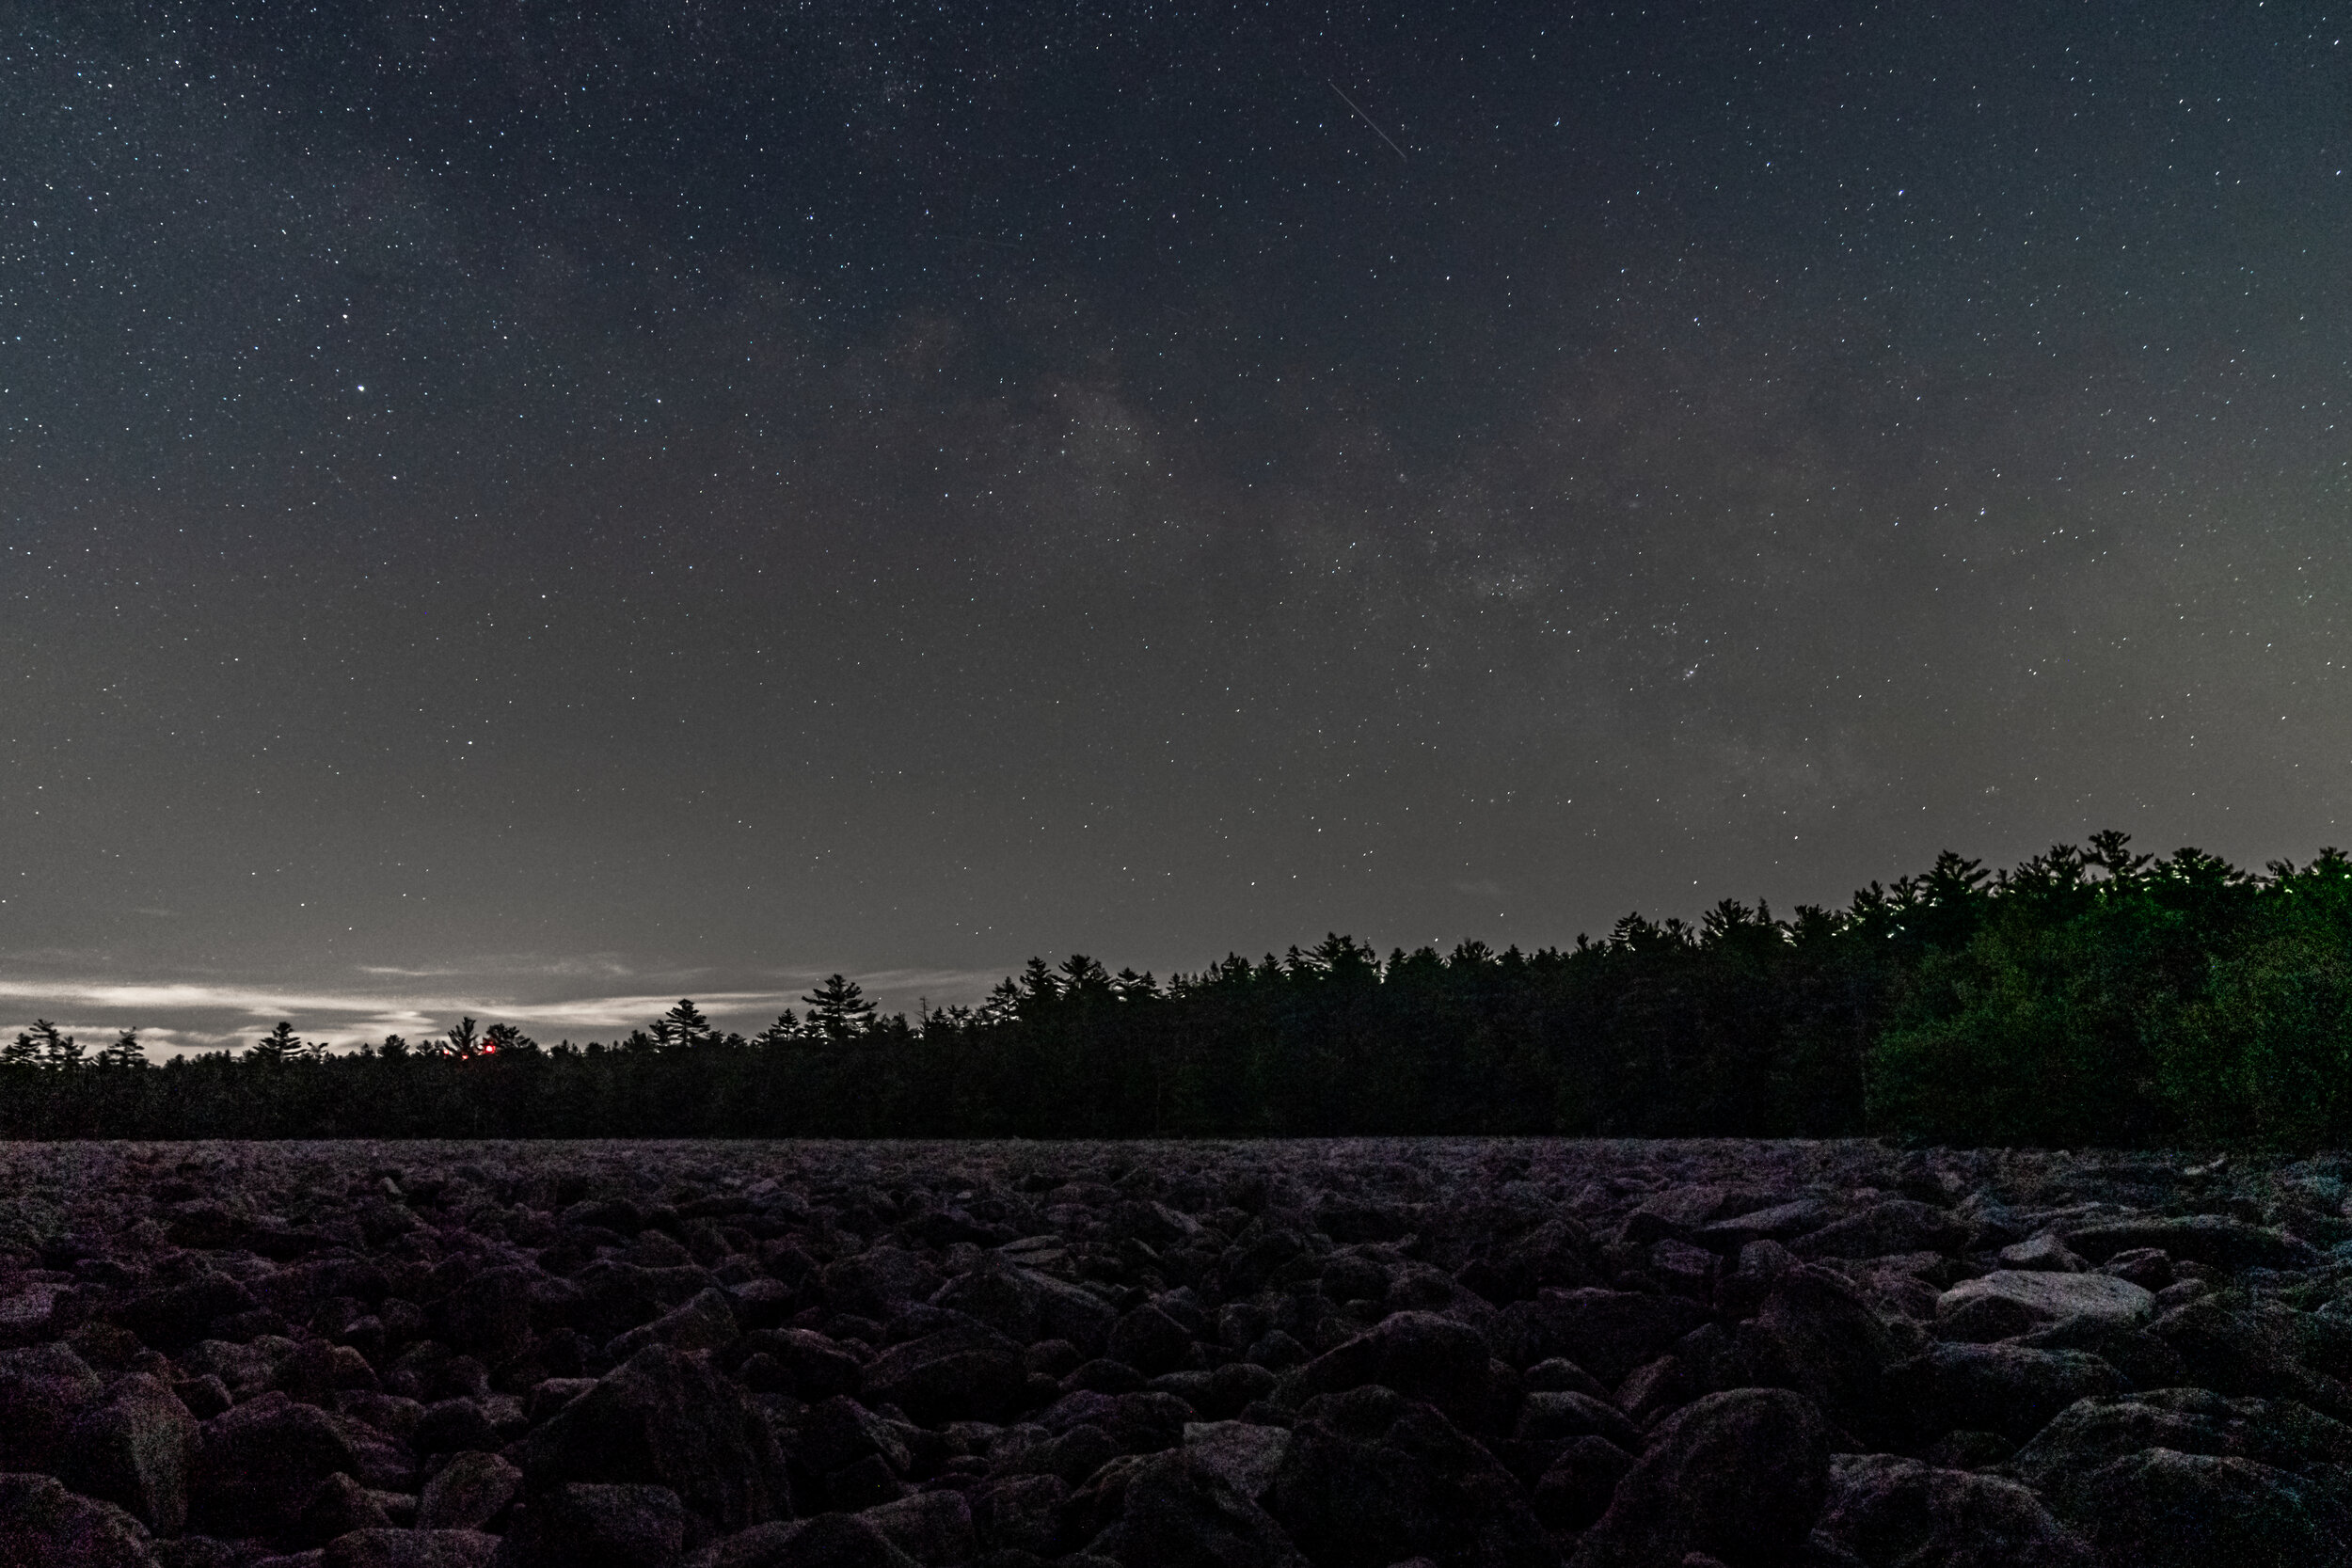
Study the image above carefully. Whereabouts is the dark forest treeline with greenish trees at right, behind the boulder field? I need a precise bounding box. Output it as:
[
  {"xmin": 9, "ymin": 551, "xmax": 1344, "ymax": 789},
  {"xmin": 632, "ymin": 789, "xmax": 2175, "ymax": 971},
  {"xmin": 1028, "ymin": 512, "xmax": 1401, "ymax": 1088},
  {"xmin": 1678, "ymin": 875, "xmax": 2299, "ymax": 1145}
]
[{"xmin": 0, "ymin": 832, "xmax": 2352, "ymax": 1148}]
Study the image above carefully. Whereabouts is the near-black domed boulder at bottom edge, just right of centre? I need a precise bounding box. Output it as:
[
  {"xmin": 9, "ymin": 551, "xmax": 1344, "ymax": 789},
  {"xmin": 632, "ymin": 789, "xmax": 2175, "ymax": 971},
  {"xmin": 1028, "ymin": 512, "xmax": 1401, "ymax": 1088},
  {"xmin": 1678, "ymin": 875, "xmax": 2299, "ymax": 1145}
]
[{"xmin": 1265, "ymin": 1385, "xmax": 1557, "ymax": 1568}]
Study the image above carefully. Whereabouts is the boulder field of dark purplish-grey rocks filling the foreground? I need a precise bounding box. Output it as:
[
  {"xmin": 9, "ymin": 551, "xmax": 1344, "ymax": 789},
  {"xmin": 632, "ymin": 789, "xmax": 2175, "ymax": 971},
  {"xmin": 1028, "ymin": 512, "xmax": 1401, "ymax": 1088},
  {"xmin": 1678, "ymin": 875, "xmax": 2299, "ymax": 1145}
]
[{"xmin": 0, "ymin": 1140, "xmax": 2352, "ymax": 1568}]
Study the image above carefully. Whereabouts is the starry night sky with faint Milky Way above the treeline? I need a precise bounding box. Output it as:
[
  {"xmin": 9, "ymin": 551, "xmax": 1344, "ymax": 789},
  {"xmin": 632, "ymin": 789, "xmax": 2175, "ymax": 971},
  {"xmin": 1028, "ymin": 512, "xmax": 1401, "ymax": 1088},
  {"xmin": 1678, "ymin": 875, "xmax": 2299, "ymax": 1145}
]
[{"xmin": 0, "ymin": 2, "xmax": 2352, "ymax": 1049}]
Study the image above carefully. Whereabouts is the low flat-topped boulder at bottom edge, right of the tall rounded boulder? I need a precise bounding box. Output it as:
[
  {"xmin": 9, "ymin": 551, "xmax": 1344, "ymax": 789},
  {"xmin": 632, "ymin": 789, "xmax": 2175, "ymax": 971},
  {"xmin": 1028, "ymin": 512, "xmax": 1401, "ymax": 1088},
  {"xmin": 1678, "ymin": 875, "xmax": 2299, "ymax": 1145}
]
[{"xmin": 1814, "ymin": 1453, "xmax": 2098, "ymax": 1568}]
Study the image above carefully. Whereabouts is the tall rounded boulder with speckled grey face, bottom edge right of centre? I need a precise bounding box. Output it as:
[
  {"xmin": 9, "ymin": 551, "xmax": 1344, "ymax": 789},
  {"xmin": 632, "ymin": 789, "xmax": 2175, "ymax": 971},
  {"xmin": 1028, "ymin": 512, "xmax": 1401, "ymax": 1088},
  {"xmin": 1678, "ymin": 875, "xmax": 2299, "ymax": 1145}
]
[{"xmin": 1571, "ymin": 1389, "xmax": 1830, "ymax": 1568}]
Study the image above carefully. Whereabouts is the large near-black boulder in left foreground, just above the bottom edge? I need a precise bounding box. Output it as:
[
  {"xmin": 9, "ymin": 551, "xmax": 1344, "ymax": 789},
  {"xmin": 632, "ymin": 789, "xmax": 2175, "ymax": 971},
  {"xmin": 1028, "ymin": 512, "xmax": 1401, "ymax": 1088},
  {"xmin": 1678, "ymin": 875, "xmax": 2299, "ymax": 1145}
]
[{"xmin": 513, "ymin": 1345, "xmax": 790, "ymax": 1530}]
